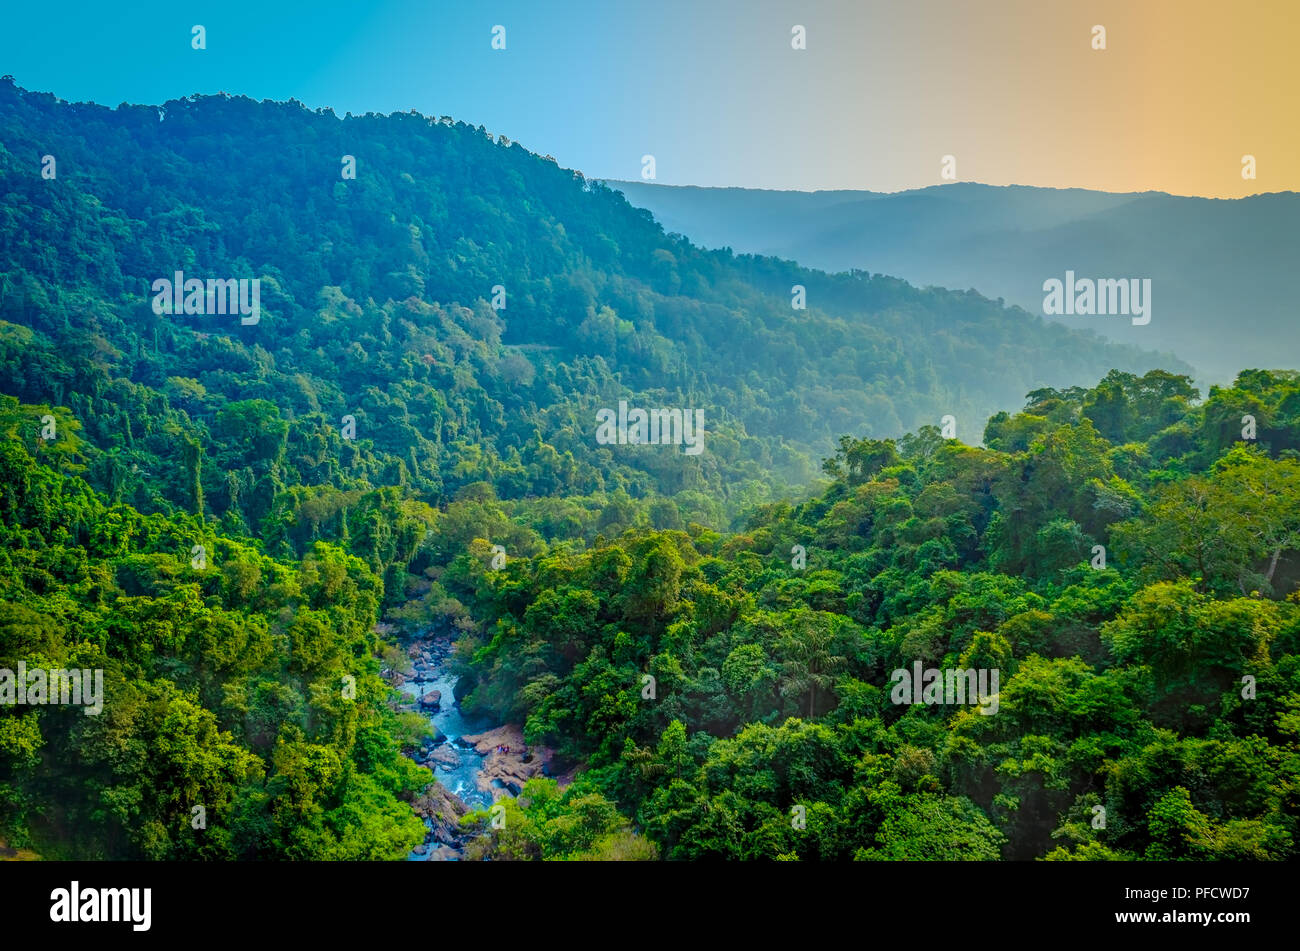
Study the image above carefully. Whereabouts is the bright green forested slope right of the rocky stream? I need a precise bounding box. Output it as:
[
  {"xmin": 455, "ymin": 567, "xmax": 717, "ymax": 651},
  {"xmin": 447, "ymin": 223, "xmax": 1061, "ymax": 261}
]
[{"xmin": 452, "ymin": 372, "xmax": 1300, "ymax": 860}]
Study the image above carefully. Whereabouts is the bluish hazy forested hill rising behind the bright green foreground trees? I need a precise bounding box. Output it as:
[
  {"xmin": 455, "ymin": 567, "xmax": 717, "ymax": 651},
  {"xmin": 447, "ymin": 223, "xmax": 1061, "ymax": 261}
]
[{"xmin": 0, "ymin": 82, "xmax": 1179, "ymax": 529}]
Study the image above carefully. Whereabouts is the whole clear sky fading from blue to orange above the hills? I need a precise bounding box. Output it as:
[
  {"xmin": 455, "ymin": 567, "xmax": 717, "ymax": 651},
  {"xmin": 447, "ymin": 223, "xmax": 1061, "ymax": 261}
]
[{"xmin": 0, "ymin": 0, "xmax": 1300, "ymax": 197}]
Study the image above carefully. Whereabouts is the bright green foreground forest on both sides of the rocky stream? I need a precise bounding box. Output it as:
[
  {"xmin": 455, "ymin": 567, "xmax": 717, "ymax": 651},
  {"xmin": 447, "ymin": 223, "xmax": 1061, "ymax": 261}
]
[{"xmin": 0, "ymin": 372, "xmax": 1300, "ymax": 859}]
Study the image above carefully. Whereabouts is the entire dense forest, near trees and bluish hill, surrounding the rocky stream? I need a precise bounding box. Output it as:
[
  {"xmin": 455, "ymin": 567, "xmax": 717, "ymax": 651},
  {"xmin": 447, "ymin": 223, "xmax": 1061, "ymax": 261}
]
[{"xmin": 0, "ymin": 78, "xmax": 1300, "ymax": 859}]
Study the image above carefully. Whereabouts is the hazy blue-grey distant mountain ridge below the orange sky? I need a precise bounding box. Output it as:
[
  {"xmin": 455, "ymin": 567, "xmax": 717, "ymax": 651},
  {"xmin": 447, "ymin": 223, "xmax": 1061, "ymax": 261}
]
[{"xmin": 610, "ymin": 182, "xmax": 1300, "ymax": 383}]
